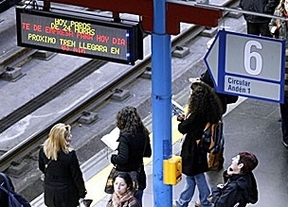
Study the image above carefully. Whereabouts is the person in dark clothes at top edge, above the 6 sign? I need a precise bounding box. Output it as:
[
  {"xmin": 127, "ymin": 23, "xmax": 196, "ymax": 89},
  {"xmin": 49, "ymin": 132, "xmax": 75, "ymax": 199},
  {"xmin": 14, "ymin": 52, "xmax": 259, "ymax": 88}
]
[{"xmin": 240, "ymin": 0, "xmax": 279, "ymax": 37}]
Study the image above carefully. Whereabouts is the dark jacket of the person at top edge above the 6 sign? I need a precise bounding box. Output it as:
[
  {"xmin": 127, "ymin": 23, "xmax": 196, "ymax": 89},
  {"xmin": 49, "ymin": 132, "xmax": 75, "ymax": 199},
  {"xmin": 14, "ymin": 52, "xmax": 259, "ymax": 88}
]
[{"xmin": 240, "ymin": 0, "xmax": 279, "ymax": 23}]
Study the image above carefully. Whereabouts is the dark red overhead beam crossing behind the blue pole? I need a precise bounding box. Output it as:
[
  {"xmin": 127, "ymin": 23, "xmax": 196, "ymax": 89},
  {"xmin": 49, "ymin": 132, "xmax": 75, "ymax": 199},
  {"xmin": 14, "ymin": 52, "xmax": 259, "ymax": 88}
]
[{"xmin": 44, "ymin": 0, "xmax": 222, "ymax": 35}]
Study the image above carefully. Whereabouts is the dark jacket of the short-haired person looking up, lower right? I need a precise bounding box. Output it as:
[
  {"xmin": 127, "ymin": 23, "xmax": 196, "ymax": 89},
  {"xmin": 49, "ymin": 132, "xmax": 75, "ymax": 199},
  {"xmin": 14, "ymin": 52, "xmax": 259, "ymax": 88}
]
[{"xmin": 212, "ymin": 171, "xmax": 258, "ymax": 207}]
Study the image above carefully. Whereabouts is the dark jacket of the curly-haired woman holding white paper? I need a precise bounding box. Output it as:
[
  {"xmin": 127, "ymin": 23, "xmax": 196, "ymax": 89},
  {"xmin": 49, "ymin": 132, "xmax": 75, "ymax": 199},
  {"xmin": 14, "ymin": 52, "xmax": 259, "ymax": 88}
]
[{"xmin": 111, "ymin": 130, "xmax": 152, "ymax": 190}]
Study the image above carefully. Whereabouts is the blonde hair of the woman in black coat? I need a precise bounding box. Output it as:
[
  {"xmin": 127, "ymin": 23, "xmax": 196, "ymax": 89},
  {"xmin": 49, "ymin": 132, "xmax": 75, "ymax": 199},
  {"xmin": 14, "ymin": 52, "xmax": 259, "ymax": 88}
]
[{"xmin": 43, "ymin": 123, "xmax": 73, "ymax": 161}]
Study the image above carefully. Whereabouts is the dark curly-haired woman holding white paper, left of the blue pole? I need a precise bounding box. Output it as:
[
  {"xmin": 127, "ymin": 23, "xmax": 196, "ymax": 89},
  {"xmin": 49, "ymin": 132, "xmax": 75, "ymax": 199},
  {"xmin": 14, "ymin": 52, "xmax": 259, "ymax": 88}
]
[{"xmin": 111, "ymin": 106, "xmax": 152, "ymax": 205}]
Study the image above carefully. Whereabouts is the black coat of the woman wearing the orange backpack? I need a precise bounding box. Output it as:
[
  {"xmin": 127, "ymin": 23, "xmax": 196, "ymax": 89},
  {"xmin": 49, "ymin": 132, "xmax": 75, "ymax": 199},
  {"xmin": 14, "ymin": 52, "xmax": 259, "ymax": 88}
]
[{"xmin": 178, "ymin": 114, "xmax": 208, "ymax": 176}]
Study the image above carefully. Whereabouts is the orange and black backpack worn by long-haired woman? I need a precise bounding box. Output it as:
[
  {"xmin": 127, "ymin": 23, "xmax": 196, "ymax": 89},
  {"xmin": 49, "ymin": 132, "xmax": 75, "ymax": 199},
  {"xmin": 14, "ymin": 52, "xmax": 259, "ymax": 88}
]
[{"xmin": 198, "ymin": 121, "xmax": 224, "ymax": 154}]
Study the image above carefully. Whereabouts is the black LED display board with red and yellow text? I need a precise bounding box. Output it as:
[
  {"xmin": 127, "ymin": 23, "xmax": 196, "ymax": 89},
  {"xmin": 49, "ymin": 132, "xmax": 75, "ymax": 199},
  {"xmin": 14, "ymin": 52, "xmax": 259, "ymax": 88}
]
[{"xmin": 16, "ymin": 8, "xmax": 143, "ymax": 64}]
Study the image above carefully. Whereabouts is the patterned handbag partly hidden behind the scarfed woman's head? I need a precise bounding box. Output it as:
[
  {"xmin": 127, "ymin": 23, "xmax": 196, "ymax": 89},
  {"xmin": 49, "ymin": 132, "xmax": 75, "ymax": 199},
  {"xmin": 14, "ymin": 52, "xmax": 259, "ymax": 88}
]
[{"xmin": 104, "ymin": 166, "xmax": 140, "ymax": 194}]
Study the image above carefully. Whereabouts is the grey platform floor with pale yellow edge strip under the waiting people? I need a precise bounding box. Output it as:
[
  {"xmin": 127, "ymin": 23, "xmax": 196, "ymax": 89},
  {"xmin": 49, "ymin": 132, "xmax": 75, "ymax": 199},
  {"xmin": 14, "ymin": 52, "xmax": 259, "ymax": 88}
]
[{"xmin": 32, "ymin": 98, "xmax": 288, "ymax": 207}]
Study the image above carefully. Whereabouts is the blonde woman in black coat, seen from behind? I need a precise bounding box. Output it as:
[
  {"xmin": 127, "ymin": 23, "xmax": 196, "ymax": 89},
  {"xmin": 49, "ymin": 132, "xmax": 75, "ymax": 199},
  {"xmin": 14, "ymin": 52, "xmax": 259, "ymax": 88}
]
[{"xmin": 38, "ymin": 123, "xmax": 86, "ymax": 207}]
